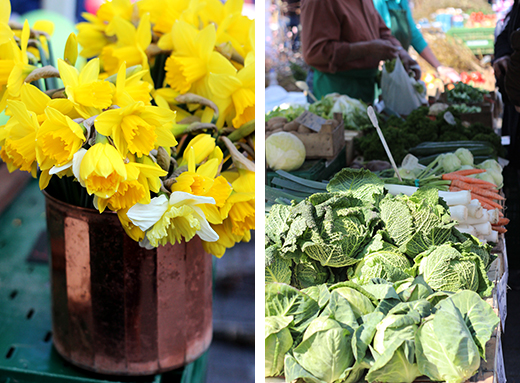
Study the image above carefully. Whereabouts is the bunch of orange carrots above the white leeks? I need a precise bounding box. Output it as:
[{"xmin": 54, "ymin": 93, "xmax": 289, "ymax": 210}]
[{"xmin": 442, "ymin": 169, "xmax": 509, "ymax": 233}]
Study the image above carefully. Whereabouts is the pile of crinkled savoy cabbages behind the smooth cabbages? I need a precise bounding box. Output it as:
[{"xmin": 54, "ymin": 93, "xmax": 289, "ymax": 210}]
[{"xmin": 265, "ymin": 169, "xmax": 494, "ymax": 296}]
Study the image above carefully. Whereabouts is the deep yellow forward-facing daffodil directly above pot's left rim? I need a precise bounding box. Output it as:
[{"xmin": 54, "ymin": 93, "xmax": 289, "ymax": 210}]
[{"xmin": 36, "ymin": 107, "xmax": 86, "ymax": 175}]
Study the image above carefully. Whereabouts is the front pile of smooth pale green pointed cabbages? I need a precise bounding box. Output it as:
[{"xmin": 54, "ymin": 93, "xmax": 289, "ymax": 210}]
[{"xmin": 265, "ymin": 277, "xmax": 499, "ymax": 383}]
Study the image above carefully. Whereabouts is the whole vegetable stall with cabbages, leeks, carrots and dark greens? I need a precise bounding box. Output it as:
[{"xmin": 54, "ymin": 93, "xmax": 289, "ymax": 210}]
[{"xmin": 265, "ymin": 77, "xmax": 509, "ymax": 382}]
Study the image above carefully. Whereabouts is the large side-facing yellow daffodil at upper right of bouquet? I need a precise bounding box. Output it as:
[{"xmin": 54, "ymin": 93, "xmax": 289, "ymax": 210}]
[{"xmin": 165, "ymin": 20, "xmax": 236, "ymax": 99}]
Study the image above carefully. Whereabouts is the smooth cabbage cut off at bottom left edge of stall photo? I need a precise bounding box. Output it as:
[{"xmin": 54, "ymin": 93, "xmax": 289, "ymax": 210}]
[{"xmin": 265, "ymin": 316, "xmax": 293, "ymax": 376}]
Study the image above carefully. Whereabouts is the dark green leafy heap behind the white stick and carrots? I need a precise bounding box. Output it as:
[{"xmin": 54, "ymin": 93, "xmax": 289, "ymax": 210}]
[{"xmin": 354, "ymin": 106, "xmax": 505, "ymax": 163}]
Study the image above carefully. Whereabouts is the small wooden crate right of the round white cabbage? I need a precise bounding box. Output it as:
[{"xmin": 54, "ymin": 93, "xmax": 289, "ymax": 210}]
[{"xmin": 291, "ymin": 113, "xmax": 345, "ymax": 160}]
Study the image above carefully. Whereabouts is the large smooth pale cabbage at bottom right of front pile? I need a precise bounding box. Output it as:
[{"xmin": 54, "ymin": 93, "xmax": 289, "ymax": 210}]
[{"xmin": 415, "ymin": 299, "xmax": 480, "ymax": 383}]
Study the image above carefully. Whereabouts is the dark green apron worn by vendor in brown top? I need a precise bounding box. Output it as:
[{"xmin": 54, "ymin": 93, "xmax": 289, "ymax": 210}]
[{"xmin": 313, "ymin": 68, "xmax": 377, "ymax": 103}]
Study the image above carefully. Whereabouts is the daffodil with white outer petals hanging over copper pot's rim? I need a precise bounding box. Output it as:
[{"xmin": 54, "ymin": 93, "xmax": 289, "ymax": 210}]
[{"xmin": 127, "ymin": 192, "xmax": 218, "ymax": 246}]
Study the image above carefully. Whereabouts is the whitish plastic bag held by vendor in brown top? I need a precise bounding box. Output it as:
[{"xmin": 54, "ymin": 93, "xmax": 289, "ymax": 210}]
[{"xmin": 381, "ymin": 58, "xmax": 427, "ymax": 115}]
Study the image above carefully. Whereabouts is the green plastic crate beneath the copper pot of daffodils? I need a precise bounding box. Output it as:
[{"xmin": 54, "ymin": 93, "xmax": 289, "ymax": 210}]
[{"xmin": 0, "ymin": 181, "xmax": 208, "ymax": 383}]
